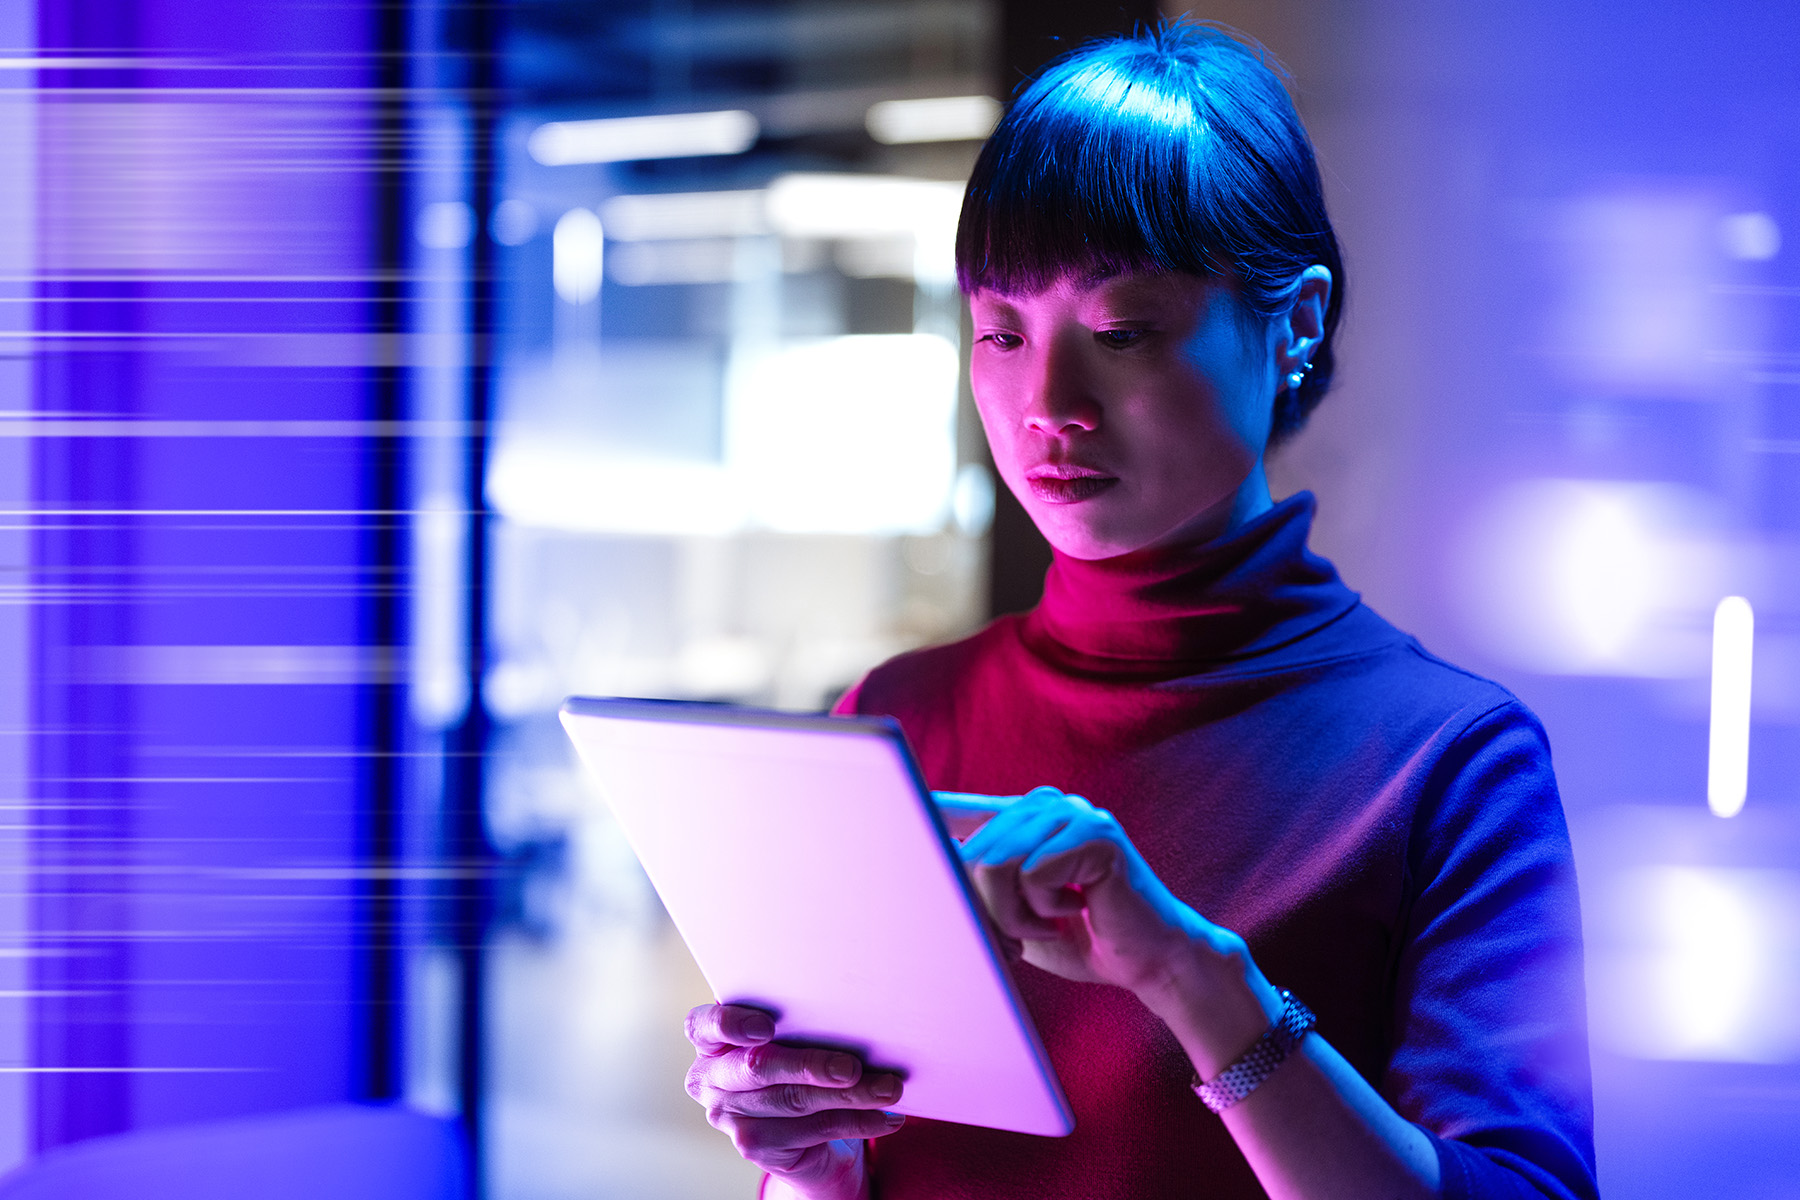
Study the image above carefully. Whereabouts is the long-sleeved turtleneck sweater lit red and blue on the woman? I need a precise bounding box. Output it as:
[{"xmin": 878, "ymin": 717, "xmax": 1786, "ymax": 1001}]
[{"xmin": 837, "ymin": 493, "xmax": 1597, "ymax": 1200}]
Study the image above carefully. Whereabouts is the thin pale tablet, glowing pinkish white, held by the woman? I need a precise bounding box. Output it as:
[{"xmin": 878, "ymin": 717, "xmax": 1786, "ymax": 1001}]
[{"xmin": 562, "ymin": 698, "xmax": 1075, "ymax": 1137}]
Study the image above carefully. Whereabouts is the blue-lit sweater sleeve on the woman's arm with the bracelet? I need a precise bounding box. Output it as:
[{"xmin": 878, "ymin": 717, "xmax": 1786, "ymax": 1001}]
[{"xmin": 1382, "ymin": 702, "xmax": 1598, "ymax": 1200}]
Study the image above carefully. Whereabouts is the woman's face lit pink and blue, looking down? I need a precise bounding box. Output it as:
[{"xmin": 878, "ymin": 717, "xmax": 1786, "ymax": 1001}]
[{"xmin": 968, "ymin": 272, "xmax": 1285, "ymax": 560}]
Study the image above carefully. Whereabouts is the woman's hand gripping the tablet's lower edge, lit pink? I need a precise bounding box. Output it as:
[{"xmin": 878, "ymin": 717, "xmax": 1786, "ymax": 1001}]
[{"xmin": 688, "ymin": 1004, "xmax": 905, "ymax": 1200}]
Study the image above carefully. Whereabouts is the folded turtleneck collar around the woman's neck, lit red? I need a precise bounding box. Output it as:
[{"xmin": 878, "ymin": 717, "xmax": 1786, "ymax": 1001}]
[{"xmin": 1021, "ymin": 491, "xmax": 1357, "ymax": 678}]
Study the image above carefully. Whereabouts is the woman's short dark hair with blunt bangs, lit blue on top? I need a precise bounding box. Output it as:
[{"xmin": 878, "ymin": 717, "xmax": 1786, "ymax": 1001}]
[{"xmin": 956, "ymin": 20, "xmax": 1345, "ymax": 444}]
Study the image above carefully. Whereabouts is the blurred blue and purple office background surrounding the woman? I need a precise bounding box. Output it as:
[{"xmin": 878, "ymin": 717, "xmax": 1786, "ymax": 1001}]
[{"xmin": 0, "ymin": 0, "xmax": 1800, "ymax": 1200}]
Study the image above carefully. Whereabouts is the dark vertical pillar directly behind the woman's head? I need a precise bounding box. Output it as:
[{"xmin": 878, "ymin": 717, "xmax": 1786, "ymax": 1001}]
[{"xmin": 988, "ymin": 0, "xmax": 1159, "ymax": 615}]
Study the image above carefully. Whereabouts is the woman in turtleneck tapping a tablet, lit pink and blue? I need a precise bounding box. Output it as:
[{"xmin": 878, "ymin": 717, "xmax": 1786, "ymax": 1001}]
[{"xmin": 689, "ymin": 25, "xmax": 1595, "ymax": 1200}]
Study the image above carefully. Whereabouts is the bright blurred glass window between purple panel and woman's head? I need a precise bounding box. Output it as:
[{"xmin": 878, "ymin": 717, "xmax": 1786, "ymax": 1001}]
[{"xmin": 464, "ymin": 0, "xmax": 999, "ymax": 1198}]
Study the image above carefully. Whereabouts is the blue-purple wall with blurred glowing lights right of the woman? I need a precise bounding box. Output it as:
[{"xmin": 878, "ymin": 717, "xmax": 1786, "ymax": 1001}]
[{"xmin": 1192, "ymin": 0, "xmax": 1800, "ymax": 1198}]
